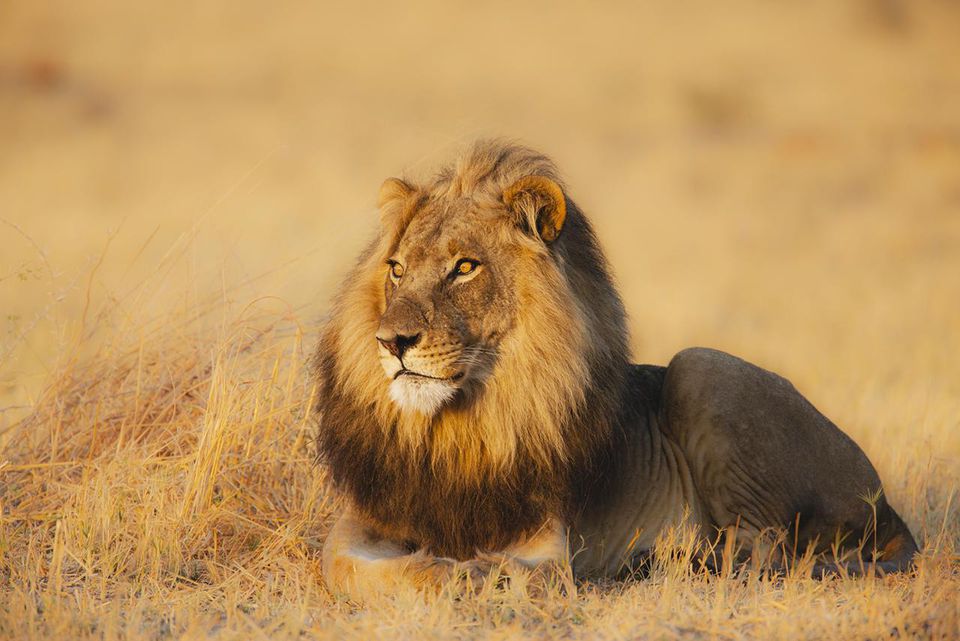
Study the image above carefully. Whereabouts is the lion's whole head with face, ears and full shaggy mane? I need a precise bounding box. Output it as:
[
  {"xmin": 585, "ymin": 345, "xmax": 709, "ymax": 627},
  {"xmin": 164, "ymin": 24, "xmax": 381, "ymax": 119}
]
[{"xmin": 317, "ymin": 141, "xmax": 627, "ymax": 556}]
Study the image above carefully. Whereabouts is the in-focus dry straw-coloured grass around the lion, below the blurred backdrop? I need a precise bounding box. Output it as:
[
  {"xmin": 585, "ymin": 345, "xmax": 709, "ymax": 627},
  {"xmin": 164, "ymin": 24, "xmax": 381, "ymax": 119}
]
[{"xmin": 0, "ymin": 264, "xmax": 960, "ymax": 639}]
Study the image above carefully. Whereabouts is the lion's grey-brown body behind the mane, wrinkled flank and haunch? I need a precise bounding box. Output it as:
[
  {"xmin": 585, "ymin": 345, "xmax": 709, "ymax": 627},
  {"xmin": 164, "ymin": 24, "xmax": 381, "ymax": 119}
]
[{"xmin": 571, "ymin": 358, "xmax": 916, "ymax": 576}]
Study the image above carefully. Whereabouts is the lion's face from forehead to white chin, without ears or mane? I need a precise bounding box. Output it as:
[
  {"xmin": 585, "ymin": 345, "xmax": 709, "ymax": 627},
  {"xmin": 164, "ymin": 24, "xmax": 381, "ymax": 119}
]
[{"xmin": 371, "ymin": 201, "xmax": 519, "ymax": 415}]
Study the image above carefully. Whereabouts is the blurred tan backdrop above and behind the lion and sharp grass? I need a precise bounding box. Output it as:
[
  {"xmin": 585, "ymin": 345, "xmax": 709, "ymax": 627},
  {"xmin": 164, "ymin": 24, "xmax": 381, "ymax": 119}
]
[{"xmin": 0, "ymin": 0, "xmax": 960, "ymax": 427}]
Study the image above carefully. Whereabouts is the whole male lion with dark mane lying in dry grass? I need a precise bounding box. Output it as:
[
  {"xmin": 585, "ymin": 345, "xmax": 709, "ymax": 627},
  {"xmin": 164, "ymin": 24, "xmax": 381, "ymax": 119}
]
[{"xmin": 316, "ymin": 141, "xmax": 917, "ymax": 599}]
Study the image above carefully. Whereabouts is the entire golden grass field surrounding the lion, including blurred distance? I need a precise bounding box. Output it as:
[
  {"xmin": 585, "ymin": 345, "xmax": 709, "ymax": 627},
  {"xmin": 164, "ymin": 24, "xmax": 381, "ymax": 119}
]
[{"xmin": 0, "ymin": 0, "xmax": 960, "ymax": 639}]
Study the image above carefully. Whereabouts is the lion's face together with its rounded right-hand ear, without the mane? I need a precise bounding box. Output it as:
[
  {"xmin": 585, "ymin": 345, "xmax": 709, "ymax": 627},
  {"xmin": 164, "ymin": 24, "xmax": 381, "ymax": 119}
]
[{"xmin": 371, "ymin": 172, "xmax": 565, "ymax": 416}]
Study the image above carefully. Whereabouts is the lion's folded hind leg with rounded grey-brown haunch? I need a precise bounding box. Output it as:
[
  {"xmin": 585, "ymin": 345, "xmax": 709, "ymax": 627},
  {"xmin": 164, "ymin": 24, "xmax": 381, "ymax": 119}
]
[{"xmin": 661, "ymin": 348, "xmax": 916, "ymax": 571}]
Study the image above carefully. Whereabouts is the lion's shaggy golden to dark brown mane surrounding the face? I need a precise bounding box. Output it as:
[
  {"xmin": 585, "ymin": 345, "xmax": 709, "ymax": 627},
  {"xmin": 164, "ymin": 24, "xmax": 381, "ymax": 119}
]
[{"xmin": 316, "ymin": 141, "xmax": 627, "ymax": 556}]
